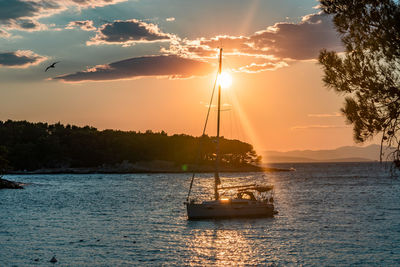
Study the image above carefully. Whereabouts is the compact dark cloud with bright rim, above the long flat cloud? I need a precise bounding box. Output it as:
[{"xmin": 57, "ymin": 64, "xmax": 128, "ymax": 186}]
[{"xmin": 87, "ymin": 19, "xmax": 173, "ymax": 45}]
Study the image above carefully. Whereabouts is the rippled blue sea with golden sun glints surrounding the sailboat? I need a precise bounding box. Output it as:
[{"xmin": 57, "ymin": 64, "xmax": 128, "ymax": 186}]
[{"xmin": 0, "ymin": 163, "xmax": 400, "ymax": 266}]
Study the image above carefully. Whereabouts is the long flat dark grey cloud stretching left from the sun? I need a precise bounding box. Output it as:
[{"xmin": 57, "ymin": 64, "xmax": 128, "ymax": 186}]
[{"xmin": 54, "ymin": 55, "xmax": 214, "ymax": 82}]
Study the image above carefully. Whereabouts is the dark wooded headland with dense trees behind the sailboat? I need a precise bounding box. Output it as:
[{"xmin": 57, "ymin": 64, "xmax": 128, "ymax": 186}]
[{"xmin": 0, "ymin": 120, "xmax": 261, "ymax": 173}]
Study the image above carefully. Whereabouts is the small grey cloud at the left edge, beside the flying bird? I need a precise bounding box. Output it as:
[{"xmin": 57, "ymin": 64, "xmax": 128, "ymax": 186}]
[{"xmin": 0, "ymin": 50, "xmax": 47, "ymax": 68}]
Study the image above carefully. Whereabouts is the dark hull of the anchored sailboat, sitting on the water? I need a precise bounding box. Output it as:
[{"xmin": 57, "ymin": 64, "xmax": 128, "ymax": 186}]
[{"xmin": 186, "ymin": 202, "xmax": 274, "ymax": 220}]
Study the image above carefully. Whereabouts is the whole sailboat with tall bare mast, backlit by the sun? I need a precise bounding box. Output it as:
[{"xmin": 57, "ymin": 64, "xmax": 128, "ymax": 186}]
[{"xmin": 185, "ymin": 48, "xmax": 276, "ymax": 220}]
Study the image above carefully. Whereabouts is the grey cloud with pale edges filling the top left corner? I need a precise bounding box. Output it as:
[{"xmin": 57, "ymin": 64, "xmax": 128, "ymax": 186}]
[{"xmin": 0, "ymin": 0, "xmax": 126, "ymax": 31}]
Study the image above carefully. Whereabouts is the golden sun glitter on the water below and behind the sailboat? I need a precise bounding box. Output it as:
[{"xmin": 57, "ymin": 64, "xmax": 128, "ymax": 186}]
[{"xmin": 185, "ymin": 173, "xmax": 276, "ymax": 266}]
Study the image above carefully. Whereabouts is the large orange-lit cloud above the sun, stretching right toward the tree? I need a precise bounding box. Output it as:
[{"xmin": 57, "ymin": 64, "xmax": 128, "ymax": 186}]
[{"xmin": 164, "ymin": 13, "xmax": 342, "ymax": 60}]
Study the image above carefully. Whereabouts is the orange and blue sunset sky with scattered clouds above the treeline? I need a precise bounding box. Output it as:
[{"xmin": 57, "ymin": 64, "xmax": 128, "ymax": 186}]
[{"xmin": 0, "ymin": 0, "xmax": 372, "ymax": 151}]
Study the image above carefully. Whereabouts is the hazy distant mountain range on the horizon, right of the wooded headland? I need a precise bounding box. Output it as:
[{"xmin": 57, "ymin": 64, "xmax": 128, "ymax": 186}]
[{"xmin": 260, "ymin": 145, "xmax": 390, "ymax": 163}]
